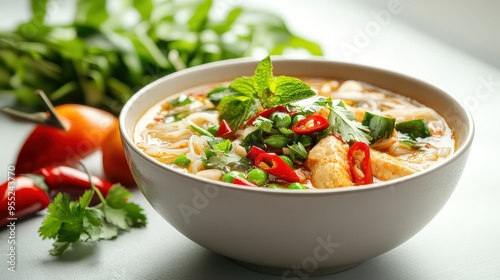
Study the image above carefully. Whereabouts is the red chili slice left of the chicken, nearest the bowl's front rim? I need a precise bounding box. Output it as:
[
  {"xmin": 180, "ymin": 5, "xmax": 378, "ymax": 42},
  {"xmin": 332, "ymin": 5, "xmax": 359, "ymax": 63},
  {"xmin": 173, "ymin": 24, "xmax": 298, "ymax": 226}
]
[{"xmin": 254, "ymin": 153, "xmax": 300, "ymax": 182}]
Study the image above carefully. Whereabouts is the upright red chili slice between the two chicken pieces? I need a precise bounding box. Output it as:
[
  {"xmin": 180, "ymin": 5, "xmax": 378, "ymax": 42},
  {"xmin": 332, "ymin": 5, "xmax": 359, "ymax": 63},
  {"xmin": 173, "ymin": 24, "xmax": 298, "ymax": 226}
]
[{"xmin": 347, "ymin": 142, "xmax": 373, "ymax": 185}]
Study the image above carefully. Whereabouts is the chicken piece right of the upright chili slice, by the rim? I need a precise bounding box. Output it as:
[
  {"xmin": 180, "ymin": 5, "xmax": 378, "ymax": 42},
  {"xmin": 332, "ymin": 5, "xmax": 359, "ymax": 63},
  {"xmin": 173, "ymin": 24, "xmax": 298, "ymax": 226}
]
[{"xmin": 370, "ymin": 149, "xmax": 417, "ymax": 181}]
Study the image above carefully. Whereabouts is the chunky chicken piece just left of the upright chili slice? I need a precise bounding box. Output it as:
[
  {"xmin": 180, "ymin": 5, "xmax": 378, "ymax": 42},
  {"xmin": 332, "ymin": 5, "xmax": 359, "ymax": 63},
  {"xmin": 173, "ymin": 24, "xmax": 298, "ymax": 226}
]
[{"xmin": 304, "ymin": 136, "xmax": 354, "ymax": 189}]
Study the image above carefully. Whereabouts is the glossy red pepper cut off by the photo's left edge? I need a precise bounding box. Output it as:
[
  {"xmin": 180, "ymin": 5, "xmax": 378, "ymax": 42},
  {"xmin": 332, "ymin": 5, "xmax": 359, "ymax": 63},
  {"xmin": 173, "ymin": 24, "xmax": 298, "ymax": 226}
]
[{"xmin": 0, "ymin": 176, "xmax": 50, "ymax": 227}]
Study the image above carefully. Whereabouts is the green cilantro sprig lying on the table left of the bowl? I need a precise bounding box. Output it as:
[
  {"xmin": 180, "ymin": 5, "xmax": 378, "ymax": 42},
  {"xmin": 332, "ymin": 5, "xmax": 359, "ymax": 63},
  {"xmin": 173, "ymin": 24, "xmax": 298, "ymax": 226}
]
[{"xmin": 38, "ymin": 165, "xmax": 147, "ymax": 256}]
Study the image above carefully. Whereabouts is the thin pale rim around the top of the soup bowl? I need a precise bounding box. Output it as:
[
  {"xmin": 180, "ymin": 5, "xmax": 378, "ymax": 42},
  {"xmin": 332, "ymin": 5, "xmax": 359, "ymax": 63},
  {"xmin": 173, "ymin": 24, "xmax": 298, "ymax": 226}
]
[{"xmin": 118, "ymin": 56, "xmax": 475, "ymax": 196}]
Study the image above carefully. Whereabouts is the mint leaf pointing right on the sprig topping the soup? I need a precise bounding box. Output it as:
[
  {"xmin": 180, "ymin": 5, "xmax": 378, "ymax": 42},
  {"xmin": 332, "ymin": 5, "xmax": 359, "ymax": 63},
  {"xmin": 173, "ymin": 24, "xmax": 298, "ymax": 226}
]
[{"xmin": 264, "ymin": 76, "xmax": 316, "ymax": 108}]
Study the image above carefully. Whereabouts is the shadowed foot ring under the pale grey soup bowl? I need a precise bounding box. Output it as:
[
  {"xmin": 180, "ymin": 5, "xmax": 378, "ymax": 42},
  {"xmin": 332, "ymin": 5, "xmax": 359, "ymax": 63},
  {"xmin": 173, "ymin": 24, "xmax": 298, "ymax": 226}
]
[{"xmin": 231, "ymin": 259, "xmax": 357, "ymax": 279}]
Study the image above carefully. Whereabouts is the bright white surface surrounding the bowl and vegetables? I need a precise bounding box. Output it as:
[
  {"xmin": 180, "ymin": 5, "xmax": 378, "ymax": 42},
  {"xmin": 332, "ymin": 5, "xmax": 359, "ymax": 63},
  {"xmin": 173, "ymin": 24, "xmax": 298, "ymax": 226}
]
[{"xmin": 0, "ymin": 0, "xmax": 500, "ymax": 279}]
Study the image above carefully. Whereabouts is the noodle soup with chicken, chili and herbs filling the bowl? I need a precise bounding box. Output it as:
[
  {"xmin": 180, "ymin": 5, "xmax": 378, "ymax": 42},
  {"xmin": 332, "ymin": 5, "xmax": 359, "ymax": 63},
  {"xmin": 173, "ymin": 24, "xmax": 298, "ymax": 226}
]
[{"xmin": 134, "ymin": 57, "xmax": 455, "ymax": 189}]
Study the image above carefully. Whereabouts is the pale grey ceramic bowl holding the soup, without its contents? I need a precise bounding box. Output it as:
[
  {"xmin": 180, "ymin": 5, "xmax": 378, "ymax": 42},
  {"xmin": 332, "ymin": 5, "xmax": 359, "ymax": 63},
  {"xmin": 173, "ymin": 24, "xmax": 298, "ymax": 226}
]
[{"xmin": 120, "ymin": 58, "xmax": 474, "ymax": 278}]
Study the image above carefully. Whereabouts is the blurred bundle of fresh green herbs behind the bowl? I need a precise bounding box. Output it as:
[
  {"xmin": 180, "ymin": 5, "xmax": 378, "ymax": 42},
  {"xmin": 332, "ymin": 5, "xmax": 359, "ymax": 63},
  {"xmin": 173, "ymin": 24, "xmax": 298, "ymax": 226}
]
[{"xmin": 0, "ymin": 0, "xmax": 321, "ymax": 114}]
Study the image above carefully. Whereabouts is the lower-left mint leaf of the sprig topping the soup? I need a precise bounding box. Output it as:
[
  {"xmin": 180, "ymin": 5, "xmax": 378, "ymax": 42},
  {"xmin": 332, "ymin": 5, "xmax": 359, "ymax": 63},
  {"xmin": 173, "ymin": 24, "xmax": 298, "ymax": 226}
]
[{"xmin": 219, "ymin": 95, "xmax": 260, "ymax": 131}]
